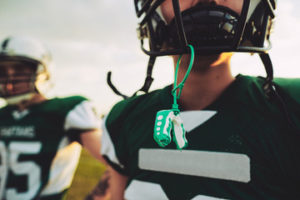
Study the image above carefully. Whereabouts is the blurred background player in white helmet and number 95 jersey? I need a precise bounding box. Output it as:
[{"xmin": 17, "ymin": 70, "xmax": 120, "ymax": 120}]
[{"xmin": 0, "ymin": 37, "xmax": 103, "ymax": 200}]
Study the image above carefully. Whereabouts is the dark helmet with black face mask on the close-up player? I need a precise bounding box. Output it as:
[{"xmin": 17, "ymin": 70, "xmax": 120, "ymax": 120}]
[{"xmin": 135, "ymin": 0, "xmax": 276, "ymax": 56}]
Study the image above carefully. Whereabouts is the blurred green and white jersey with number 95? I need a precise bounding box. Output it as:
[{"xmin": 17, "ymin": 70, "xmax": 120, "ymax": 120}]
[{"xmin": 0, "ymin": 96, "xmax": 99, "ymax": 200}]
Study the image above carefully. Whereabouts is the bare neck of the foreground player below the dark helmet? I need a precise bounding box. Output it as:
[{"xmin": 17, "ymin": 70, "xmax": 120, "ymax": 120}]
[{"xmin": 178, "ymin": 57, "xmax": 235, "ymax": 110}]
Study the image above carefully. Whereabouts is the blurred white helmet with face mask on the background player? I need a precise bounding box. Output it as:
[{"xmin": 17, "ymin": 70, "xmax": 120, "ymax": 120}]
[{"xmin": 0, "ymin": 37, "xmax": 51, "ymax": 104}]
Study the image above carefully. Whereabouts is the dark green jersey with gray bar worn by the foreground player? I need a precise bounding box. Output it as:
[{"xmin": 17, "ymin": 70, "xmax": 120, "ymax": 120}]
[{"xmin": 101, "ymin": 75, "xmax": 300, "ymax": 200}]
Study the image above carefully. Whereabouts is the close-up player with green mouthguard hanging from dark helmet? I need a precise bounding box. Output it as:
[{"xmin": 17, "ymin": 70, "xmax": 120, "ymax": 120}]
[{"xmin": 101, "ymin": 0, "xmax": 300, "ymax": 200}]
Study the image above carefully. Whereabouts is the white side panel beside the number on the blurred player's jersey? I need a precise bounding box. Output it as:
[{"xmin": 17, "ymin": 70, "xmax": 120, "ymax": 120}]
[{"xmin": 41, "ymin": 137, "xmax": 81, "ymax": 196}]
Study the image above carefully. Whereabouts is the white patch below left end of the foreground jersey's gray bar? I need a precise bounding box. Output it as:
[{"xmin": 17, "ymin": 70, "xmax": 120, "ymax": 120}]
[{"xmin": 125, "ymin": 180, "xmax": 168, "ymax": 200}]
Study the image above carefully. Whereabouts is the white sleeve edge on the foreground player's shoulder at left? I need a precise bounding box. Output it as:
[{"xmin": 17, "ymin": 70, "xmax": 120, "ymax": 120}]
[{"xmin": 101, "ymin": 116, "xmax": 124, "ymax": 168}]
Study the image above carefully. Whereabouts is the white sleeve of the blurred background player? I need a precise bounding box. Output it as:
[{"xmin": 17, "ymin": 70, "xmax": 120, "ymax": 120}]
[{"xmin": 64, "ymin": 100, "xmax": 101, "ymax": 130}]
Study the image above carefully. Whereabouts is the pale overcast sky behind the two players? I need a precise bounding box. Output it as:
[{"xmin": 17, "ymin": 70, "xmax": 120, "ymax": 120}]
[{"xmin": 0, "ymin": 0, "xmax": 300, "ymax": 113}]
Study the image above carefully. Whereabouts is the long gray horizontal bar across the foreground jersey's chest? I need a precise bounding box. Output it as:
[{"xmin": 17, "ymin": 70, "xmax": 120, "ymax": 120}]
[{"xmin": 139, "ymin": 149, "xmax": 251, "ymax": 183}]
